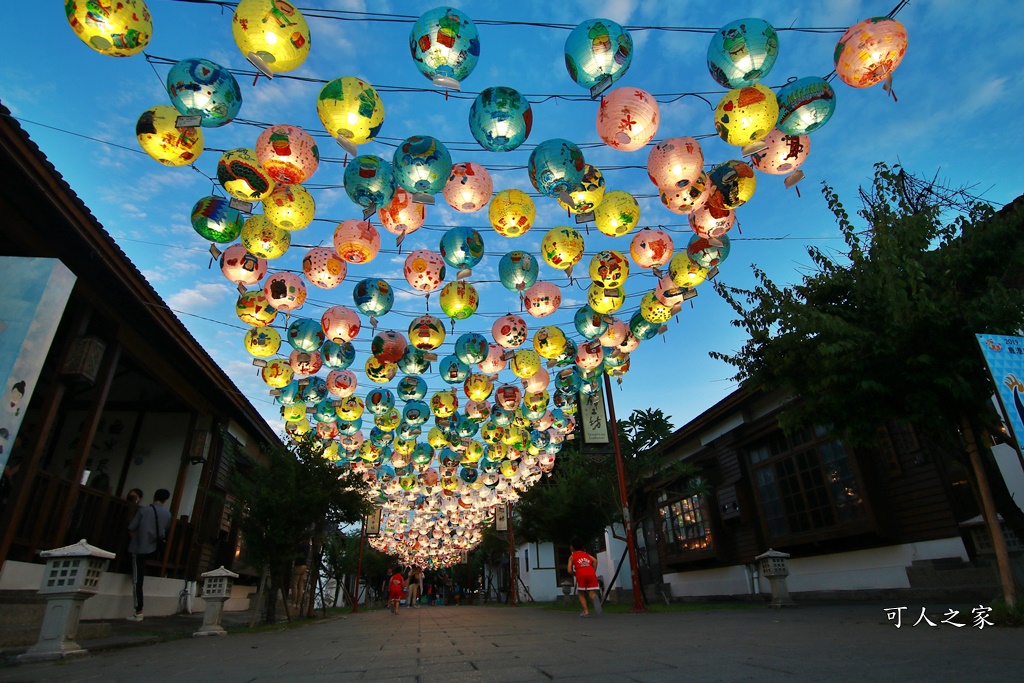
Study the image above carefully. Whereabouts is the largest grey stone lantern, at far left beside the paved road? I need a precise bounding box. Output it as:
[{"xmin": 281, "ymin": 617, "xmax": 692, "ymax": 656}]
[{"xmin": 18, "ymin": 539, "xmax": 115, "ymax": 661}]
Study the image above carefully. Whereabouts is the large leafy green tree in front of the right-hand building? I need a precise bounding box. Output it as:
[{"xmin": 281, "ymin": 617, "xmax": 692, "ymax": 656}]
[{"xmin": 711, "ymin": 164, "xmax": 1024, "ymax": 602}]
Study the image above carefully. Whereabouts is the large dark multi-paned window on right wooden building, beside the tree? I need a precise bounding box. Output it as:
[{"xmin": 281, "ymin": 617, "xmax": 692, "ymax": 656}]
[{"xmin": 748, "ymin": 427, "xmax": 867, "ymax": 537}]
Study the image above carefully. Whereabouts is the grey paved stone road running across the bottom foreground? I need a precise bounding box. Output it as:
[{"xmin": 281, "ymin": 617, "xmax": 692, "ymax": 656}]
[{"xmin": 0, "ymin": 604, "xmax": 1024, "ymax": 683}]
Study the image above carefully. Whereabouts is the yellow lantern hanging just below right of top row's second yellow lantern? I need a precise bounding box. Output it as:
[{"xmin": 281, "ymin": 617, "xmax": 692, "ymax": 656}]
[{"xmin": 316, "ymin": 76, "xmax": 384, "ymax": 148}]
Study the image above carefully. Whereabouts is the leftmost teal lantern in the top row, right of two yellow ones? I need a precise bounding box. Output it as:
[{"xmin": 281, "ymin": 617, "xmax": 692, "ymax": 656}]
[{"xmin": 409, "ymin": 7, "xmax": 480, "ymax": 90}]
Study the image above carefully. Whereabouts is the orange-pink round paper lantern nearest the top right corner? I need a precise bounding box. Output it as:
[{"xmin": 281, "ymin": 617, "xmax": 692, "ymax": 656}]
[{"xmin": 835, "ymin": 16, "xmax": 907, "ymax": 89}]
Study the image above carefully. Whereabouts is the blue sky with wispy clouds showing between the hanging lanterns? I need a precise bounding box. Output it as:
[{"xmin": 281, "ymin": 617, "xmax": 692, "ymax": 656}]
[{"xmin": 0, "ymin": 0, "xmax": 1024, "ymax": 438}]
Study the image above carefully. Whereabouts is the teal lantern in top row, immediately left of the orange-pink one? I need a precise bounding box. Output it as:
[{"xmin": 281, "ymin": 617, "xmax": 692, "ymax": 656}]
[{"xmin": 708, "ymin": 18, "xmax": 778, "ymax": 88}]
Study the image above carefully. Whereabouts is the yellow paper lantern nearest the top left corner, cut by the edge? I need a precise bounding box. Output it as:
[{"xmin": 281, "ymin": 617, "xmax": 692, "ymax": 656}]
[{"xmin": 65, "ymin": 0, "xmax": 153, "ymax": 57}]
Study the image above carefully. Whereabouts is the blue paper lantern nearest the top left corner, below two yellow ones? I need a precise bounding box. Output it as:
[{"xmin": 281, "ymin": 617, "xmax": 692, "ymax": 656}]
[{"xmin": 167, "ymin": 58, "xmax": 242, "ymax": 128}]
